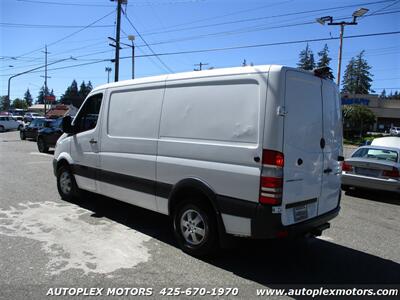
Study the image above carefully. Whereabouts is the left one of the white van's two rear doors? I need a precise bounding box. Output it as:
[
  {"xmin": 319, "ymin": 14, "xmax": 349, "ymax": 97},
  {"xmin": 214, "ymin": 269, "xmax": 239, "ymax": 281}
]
[{"xmin": 282, "ymin": 70, "xmax": 324, "ymax": 225}]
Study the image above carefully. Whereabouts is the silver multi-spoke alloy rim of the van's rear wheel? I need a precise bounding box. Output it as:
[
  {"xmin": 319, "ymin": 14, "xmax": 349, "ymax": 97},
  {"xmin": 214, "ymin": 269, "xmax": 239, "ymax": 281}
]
[{"xmin": 181, "ymin": 209, "xmax": 207, "ymax": 246}]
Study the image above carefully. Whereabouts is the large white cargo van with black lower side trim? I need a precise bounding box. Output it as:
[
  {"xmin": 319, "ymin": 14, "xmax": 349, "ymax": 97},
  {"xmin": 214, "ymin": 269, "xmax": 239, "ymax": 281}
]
[{"xmin": 54, "ymin": 65, "xmax": 343, "ymax": 255}]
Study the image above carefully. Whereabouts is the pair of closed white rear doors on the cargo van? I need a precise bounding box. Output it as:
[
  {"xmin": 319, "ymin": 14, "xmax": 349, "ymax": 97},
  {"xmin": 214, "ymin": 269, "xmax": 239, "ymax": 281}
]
[{"xmin": 282, "ymin": 70, "xmax": 343, "ymax": 225}]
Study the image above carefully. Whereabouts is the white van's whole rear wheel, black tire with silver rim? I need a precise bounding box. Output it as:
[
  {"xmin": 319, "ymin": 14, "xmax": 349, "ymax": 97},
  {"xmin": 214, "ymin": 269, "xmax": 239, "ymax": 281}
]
[{"xmin": 173, "ymin": 198, "xmax": 218, "ymax": 256}]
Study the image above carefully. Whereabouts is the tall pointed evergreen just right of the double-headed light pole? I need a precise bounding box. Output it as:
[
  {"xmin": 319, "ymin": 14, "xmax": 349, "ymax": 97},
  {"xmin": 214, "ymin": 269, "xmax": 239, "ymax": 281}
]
[{"xmin": 342, "ymin": 50, "xmax": 374, "ymax": 94}]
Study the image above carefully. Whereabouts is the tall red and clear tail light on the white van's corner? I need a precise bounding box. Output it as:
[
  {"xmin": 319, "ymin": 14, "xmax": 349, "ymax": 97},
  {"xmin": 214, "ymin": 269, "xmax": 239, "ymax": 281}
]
[{"xmin": 259, "ymin": 150, "xmax": 285, "ymax": 205}]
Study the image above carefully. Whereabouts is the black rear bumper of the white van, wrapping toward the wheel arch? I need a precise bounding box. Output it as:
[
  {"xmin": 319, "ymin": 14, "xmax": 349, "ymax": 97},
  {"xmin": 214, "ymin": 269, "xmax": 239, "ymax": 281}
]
[{"xmin": 217, "ymin": 196, "xmax": 340, "ymax": 239}]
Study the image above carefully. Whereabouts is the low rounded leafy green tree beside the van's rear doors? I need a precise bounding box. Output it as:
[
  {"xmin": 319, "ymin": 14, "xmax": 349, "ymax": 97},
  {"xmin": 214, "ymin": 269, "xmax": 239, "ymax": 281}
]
[{"xmin": 342, "ymin": 105, "xmax": 375, "ymax": 136}]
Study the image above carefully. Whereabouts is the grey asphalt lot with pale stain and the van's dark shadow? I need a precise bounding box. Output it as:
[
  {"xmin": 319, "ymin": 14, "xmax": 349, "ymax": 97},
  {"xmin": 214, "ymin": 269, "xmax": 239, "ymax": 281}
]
[{"xmin": 0, "ymin": 131, "xmax": 400, "ymax": 299}]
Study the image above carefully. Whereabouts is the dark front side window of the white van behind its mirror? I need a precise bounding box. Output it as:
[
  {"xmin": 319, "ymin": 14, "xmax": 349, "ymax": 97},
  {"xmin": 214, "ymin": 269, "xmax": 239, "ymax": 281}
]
[{"xmin": 74, "ymin": 94, "xmax": 103, "ymax": 132}]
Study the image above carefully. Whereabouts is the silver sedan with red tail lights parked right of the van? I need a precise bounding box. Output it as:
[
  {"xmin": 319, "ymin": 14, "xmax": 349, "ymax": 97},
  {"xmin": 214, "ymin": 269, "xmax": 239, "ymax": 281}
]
[{"xmin": 342, "ymin": 146, "xmax": 400, "ymax": 193}]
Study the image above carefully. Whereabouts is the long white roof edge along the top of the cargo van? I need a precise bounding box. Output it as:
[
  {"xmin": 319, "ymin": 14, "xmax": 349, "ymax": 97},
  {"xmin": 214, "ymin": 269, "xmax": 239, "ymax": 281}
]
[{"xmin": 93, "ymin": 65, "xmax": 310, "ymax": 92}]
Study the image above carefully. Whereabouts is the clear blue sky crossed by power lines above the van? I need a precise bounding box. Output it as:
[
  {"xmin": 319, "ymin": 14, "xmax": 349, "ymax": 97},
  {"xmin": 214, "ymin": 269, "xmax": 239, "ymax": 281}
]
[{"xmin": 0, "ymin": 0, "xmax": 400, "ymax": 99}]
